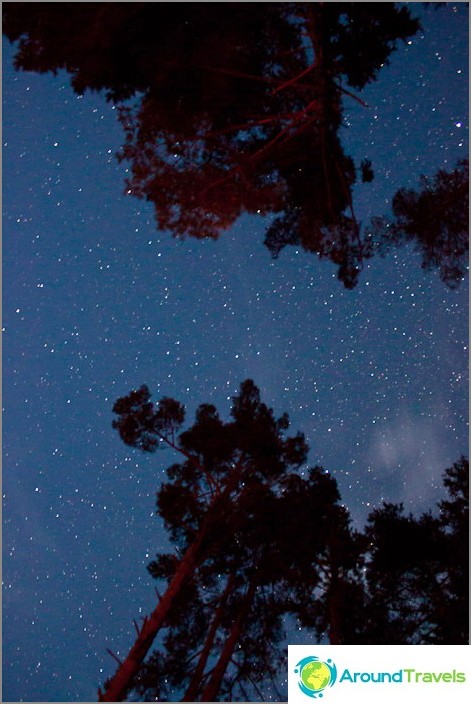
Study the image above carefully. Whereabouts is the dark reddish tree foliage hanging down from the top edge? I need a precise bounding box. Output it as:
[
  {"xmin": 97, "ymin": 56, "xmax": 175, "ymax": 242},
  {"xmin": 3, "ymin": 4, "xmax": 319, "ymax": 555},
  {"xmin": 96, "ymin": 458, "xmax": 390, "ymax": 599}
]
[{"xmin": 9, "ymin": 2, "xmax": 467, "ymax": 288}]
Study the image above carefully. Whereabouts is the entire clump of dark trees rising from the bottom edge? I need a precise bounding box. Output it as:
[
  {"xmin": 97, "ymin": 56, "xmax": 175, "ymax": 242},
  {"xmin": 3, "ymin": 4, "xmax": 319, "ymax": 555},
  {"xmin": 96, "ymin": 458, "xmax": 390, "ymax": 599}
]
[{"xmin": 100, "ymin": 380, "xmax": 469, "ymax": 701}]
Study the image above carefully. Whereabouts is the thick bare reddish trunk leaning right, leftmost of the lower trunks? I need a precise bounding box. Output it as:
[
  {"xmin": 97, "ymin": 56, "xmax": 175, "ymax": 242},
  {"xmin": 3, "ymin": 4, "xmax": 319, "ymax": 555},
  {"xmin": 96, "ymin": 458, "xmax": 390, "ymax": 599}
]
[{"xmin": 98, "ymin": 521, "xmax": 208, "ymax": 702}]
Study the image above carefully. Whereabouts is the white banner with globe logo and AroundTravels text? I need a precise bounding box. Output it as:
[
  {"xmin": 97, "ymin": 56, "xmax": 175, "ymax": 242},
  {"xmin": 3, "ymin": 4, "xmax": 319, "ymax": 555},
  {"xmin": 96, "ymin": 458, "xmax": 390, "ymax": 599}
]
[{"xmin": 288, "ymin": 645, "xmax": 471, "ymax": 704}]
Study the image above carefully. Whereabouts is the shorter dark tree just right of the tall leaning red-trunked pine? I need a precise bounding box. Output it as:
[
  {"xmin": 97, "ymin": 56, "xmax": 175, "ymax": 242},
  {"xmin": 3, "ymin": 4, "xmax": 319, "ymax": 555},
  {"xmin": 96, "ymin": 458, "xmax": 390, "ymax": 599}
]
[{"xmin": 276, "ymin": 467, "xmax": 365, "ymax": 645}]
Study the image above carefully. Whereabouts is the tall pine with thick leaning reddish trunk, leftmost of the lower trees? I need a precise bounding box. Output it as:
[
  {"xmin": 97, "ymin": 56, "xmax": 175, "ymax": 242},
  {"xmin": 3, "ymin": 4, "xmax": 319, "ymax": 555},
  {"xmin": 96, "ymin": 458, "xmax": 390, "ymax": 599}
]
[{"xmin": 100, "ymin": 380, "xmax": 307, "ymax": 701}]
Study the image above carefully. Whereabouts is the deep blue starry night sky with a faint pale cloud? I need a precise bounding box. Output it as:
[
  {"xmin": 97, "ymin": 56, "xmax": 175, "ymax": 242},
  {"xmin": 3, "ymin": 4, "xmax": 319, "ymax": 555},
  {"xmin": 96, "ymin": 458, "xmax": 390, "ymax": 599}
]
[{"xmin": 3, "ymin": 3, "xmax": 468, "ymax": 701}]
